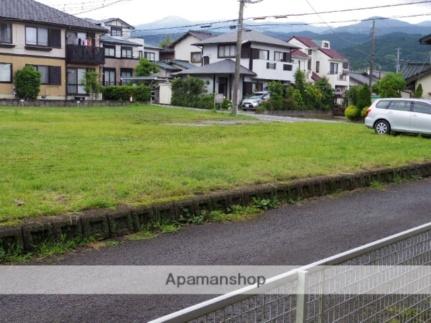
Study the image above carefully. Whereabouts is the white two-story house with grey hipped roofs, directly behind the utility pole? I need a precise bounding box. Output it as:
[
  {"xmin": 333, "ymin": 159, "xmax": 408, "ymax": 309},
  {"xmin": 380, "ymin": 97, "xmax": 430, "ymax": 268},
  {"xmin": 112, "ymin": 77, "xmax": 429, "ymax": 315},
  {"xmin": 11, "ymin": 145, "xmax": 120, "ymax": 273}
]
[{"xmin": 178, "ymin": 30, "xmax": 302, "ymax": 99}]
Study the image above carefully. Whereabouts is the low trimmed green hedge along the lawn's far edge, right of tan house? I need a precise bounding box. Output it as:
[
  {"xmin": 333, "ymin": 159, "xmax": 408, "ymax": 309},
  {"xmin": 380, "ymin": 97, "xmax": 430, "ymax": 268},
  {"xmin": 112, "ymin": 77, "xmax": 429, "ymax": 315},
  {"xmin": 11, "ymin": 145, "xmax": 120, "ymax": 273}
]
[{"xmin": 102, "ymin": 84, "xmax": 151, "ymax": 102}]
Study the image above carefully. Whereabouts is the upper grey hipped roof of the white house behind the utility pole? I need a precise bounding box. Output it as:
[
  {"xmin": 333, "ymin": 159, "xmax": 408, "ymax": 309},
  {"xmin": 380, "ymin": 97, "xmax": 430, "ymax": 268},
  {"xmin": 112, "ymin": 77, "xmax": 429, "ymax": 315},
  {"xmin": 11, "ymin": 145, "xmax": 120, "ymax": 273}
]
[{"xmin": 195, "ymin": 30, "xmax": 298, "ymax": 48}]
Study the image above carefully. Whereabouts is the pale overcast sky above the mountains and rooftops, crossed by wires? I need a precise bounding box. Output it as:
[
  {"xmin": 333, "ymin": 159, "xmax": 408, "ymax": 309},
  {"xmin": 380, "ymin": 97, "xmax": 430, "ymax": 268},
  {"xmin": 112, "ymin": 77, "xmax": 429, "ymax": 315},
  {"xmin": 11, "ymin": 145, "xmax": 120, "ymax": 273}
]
[{"xmin": 39, "ymin": 0, "xmax": 431, "ymax": 25}]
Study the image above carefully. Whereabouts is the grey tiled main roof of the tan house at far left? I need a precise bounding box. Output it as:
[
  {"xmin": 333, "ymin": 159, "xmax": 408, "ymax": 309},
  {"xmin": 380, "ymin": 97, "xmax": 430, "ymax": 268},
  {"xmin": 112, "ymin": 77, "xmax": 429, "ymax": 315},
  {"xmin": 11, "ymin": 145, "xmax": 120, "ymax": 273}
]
[{"xmin": 0, "ymin": 0, "xmax": 106, "ymax": 32}]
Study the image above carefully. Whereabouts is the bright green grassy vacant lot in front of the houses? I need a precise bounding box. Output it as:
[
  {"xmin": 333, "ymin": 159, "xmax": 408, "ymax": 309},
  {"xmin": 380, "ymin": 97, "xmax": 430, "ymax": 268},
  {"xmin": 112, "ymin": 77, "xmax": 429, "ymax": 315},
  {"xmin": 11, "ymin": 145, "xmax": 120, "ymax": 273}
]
[{"xmin": 0, "ymin": 106, "xmax": 431, "ymax": 224}]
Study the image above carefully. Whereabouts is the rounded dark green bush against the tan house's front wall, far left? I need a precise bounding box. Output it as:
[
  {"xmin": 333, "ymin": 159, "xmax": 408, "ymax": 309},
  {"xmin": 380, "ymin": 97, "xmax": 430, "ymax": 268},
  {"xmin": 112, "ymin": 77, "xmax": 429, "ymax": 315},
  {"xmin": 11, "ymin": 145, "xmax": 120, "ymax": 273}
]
[{"xmin": 15, "ymin": 65, "xmax": 40, "ymax": 100}]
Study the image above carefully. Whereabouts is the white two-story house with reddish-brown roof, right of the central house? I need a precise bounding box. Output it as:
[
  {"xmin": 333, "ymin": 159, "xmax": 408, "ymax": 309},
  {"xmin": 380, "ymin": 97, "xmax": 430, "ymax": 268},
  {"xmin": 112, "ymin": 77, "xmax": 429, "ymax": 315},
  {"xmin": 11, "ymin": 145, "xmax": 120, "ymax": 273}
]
[{"xmin": 287, "ymin": 36, "xmax": 349, "ymax": 101}]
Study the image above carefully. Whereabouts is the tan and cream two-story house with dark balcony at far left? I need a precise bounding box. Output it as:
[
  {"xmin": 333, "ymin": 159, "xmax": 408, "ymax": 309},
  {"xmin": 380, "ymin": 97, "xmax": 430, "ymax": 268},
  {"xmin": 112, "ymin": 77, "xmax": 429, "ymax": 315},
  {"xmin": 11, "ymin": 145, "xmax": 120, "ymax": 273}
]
[{"xmin": 0, "ymin": 0, "xmax": 105, "ymax": 100}]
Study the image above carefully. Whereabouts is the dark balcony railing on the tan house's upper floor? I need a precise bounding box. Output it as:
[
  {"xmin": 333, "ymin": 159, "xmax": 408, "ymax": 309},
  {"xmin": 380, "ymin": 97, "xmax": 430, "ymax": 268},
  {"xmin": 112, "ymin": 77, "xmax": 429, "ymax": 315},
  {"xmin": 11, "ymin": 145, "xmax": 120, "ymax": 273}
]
[{"xmin": 66, "ymin": 45, "xmax": 105, "ymax": 65}]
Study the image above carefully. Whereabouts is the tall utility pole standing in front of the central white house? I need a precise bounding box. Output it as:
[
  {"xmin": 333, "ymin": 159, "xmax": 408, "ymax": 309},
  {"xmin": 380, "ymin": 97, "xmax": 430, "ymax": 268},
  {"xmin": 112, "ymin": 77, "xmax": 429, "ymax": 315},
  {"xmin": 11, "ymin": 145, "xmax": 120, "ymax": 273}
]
[{"xmin": 232, "ymin": 0, "xmax": 263, "ymax": 115}]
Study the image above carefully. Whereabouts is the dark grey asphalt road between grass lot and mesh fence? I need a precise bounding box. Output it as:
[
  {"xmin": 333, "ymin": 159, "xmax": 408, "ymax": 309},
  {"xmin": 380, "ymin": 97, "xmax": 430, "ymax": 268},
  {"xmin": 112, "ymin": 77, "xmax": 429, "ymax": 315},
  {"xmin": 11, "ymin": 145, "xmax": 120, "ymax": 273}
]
[{"xmin": 0, "ymin": 179, "xmax": 431, "ymax": 322}]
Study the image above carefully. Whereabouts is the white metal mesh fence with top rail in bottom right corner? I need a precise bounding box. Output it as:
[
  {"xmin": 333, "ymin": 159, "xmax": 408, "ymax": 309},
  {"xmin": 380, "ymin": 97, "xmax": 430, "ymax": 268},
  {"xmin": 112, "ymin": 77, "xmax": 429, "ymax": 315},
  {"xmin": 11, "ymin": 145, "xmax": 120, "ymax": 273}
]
[{"xmin": 151, "ymin": 223, "xmax": 431, "ymax": 323}]
